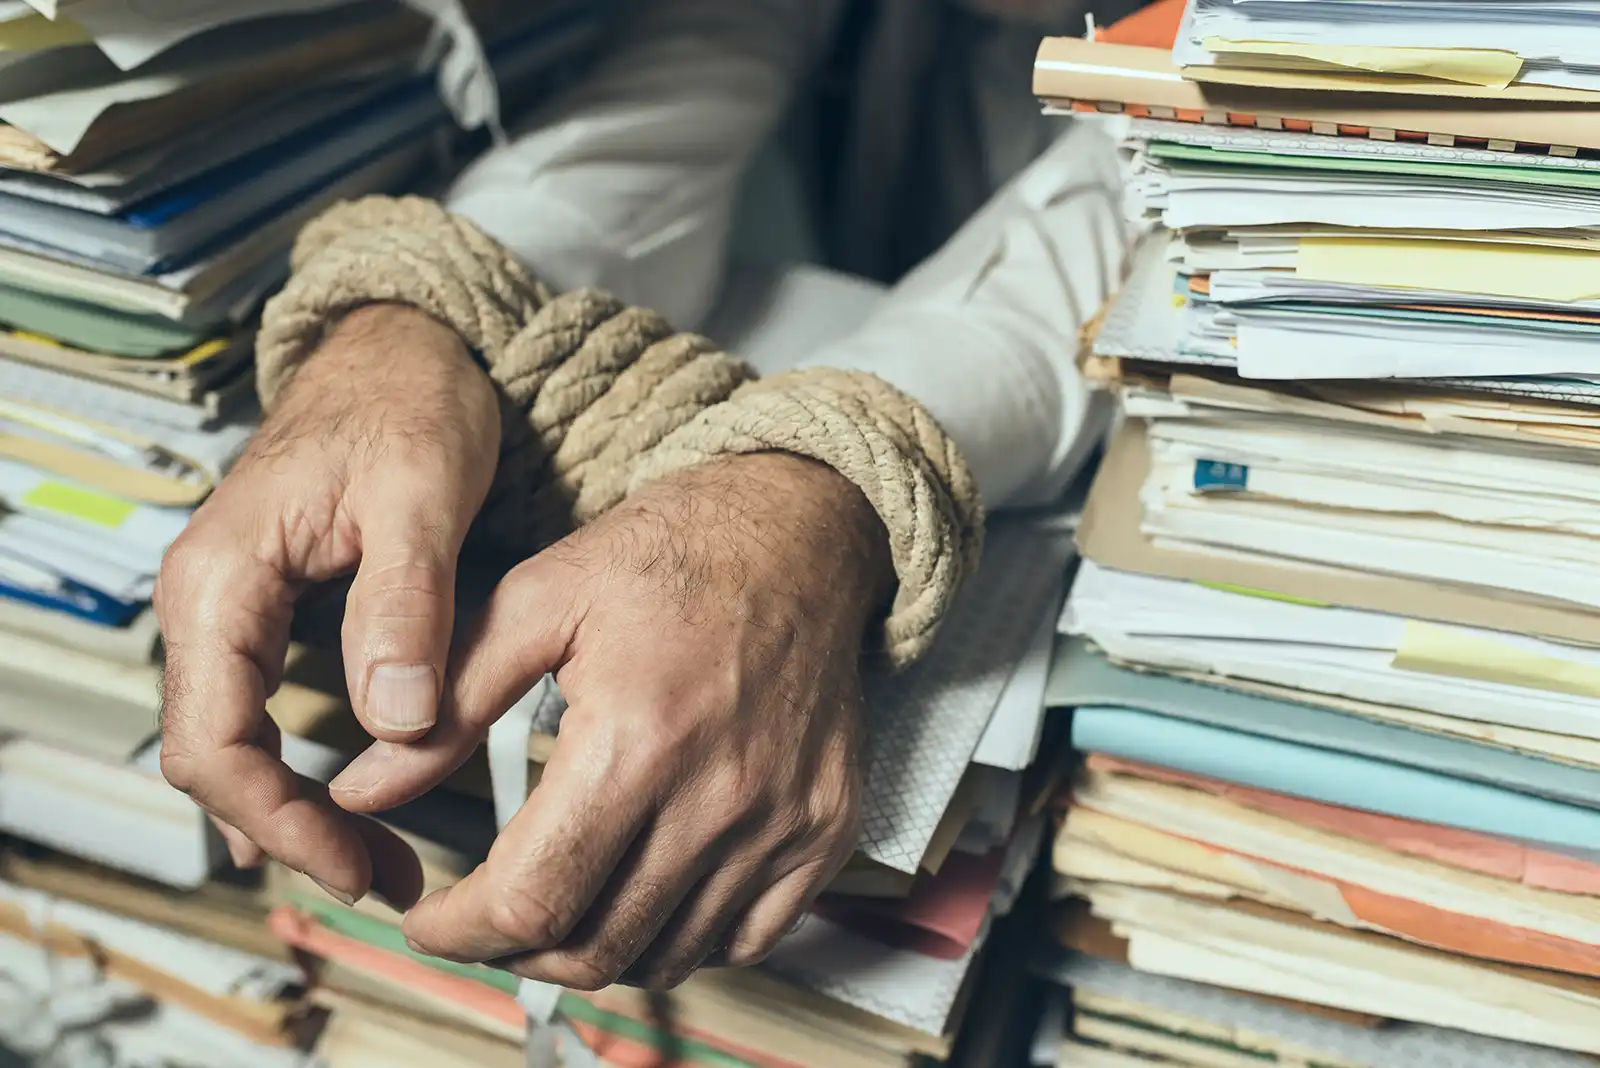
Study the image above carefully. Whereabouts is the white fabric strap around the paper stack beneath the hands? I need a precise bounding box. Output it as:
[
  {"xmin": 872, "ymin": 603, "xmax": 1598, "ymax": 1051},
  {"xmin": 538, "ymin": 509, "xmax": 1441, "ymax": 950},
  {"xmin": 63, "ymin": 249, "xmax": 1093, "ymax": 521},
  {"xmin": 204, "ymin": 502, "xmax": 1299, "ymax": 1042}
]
[{"xmin": 488, "ymin": 676, "xmax": 600, "ymax": 1068}]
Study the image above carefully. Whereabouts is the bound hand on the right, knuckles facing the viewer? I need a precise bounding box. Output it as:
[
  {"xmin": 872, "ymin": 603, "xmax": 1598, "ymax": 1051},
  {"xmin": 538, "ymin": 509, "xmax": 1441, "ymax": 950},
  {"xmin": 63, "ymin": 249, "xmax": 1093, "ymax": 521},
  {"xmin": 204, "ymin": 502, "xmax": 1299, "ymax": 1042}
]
[{"xmin": 331, "ymin": 454, "xmax": 893, "ymax": 990}]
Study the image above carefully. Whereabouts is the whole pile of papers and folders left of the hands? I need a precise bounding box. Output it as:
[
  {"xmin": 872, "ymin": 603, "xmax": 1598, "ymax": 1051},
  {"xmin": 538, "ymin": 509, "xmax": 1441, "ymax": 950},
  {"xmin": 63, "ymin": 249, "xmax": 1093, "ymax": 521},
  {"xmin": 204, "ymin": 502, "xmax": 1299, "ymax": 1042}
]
[{"xmin": 0, "ymin": 0, "xmax": 595, "ymax": 1065}]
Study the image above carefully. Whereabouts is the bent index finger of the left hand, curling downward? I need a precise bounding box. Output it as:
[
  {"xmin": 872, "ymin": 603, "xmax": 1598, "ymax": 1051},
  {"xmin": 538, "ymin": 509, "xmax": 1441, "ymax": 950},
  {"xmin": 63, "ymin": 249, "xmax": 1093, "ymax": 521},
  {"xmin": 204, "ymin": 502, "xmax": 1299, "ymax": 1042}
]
[{"xmin": 155, "ymin": 534, "xmax": 373, "ymax": 900}]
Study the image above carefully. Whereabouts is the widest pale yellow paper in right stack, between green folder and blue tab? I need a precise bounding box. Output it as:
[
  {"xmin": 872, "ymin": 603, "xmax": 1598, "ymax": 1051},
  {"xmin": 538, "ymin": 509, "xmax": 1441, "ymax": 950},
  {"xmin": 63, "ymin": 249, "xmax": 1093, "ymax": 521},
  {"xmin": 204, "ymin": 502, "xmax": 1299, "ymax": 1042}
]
[{"xmin": 1294, "ymin": 237, "xmax": 1600, "ymax": 301}]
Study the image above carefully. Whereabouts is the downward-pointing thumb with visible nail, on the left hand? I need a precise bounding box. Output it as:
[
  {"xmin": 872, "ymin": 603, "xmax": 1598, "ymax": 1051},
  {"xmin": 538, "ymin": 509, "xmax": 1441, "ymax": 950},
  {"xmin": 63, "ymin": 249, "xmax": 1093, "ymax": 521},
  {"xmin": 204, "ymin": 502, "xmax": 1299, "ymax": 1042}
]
[{"xmin": 342, "ymin": 492, "xmax": 466, "ymax": 742}]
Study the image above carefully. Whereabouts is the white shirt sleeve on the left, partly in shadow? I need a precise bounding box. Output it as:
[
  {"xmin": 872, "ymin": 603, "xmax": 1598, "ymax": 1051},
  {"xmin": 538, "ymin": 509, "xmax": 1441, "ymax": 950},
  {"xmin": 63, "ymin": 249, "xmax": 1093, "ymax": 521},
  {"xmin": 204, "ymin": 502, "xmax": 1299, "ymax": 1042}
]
[{"xmin": 446, "ymin": 0, "xmax": 840, "ymax": 329}]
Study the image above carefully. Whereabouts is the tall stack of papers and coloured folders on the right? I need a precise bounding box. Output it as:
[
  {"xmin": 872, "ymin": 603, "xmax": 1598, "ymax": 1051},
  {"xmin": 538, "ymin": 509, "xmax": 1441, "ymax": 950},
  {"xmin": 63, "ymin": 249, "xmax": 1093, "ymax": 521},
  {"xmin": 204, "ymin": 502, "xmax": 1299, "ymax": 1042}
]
[{"xmin": 1035, "ymin": 0, "xmax": 1600, "ymax": 1066}]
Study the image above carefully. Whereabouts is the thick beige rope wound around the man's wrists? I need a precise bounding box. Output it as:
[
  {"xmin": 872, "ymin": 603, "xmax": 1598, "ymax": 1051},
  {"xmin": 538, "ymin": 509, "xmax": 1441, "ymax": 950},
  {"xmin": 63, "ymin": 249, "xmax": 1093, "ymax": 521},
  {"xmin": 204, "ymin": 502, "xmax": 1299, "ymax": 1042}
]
[{"xmin": 258, "ymin": 197, "xmax": 982, "ymax": 664}]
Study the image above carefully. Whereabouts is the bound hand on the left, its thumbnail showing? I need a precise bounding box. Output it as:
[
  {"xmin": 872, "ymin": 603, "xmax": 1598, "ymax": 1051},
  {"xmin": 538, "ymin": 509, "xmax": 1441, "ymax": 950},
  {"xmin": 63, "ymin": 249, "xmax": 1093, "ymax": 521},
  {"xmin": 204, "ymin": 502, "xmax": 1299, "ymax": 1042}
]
[{"xmin": 155, "ymin": 305, "xmax": 499, "ymax": 908}]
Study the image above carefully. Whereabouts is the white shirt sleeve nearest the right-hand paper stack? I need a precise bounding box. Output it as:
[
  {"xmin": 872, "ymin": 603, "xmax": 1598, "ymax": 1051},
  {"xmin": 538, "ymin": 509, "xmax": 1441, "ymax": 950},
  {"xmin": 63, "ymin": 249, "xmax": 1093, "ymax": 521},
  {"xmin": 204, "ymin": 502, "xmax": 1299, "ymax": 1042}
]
[{"xmin": 805, "ymin": 122, "xmax": 1131, "ymax": 508}]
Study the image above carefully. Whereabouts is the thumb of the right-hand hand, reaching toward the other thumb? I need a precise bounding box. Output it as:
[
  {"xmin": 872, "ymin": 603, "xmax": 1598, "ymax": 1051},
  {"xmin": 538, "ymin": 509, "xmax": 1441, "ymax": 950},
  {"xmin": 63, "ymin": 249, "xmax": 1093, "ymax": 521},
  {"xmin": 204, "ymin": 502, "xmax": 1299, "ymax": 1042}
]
[{"xmin": 330, "ymin": 556, "xmax": 589, "ymax": 812}]
